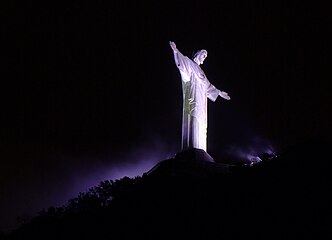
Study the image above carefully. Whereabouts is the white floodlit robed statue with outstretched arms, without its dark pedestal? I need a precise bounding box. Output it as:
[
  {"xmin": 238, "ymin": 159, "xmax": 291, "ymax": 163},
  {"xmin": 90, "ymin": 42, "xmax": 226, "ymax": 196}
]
[{"xmin": 169, "ymin": 42, "xmax": 231, "ymax": 151}]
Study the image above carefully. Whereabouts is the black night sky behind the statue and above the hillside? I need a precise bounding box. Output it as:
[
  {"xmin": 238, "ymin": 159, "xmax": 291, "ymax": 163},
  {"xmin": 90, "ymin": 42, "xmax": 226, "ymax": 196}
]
[{"xmin": 0, "ymin": 1, "xmax": 332, "ymax": 230}]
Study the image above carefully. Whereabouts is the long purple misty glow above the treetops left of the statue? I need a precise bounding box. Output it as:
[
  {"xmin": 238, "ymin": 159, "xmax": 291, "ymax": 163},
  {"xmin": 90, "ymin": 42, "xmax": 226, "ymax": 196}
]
[{"xmin": 0, "ymin": 140, "xmax": 176, "ymax": 230}]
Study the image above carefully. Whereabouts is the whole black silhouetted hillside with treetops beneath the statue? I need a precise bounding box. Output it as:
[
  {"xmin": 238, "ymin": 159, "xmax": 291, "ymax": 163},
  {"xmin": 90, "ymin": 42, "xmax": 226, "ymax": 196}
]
[{"xmin": 3, "ymin": 143, "xmax": 332, "ymax": 240}]
